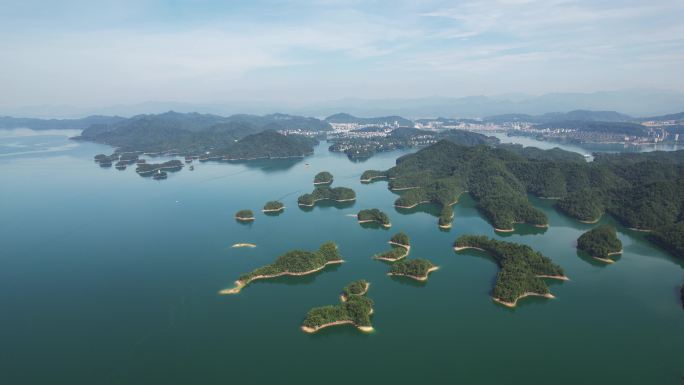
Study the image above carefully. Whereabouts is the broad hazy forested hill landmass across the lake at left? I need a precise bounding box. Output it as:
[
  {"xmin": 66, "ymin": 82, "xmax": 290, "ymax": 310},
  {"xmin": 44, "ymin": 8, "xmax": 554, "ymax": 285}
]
[{"xmin": 73, "ymin": 112, "xmax": 324, "ymax": 160}]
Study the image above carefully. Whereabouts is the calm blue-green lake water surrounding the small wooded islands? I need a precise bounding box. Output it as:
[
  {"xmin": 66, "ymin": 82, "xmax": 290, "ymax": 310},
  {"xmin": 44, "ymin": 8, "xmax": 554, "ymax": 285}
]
[{"xmin": 0, "ymin": 132, "xmax": 684, "ymax": 385}]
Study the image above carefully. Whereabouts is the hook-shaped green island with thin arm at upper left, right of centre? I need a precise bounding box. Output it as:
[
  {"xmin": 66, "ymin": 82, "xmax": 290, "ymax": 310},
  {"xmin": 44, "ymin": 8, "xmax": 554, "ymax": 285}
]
[{"xmin": 454, "ymin": 235, "xmax": 568, "ymax": 307}]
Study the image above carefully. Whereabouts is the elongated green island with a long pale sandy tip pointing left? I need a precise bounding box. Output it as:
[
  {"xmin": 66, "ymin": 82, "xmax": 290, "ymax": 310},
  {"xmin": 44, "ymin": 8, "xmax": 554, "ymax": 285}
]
[{"xmin": 219, "ymin": 242, "xmax": 344, "ymax": 294}]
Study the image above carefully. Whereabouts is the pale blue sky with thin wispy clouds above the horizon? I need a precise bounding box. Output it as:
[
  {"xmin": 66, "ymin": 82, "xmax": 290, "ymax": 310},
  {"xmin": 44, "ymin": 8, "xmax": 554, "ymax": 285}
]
[{"xmin": 0, "ymin": 0, "xmax": 684, "ymax": 107}]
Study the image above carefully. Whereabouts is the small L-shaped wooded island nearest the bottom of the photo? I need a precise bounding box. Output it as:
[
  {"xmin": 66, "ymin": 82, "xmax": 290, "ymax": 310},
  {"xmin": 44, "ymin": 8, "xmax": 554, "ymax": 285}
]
[{"xmin": 302, "ymin": 280, "xmax": 373, "ymax": 333}]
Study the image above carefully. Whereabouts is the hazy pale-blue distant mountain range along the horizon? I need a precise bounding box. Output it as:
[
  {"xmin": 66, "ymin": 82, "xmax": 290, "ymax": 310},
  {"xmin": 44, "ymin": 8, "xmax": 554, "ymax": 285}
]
[{"xmin": 0, "ymin": 89, "xmax": 684, "ymax": 119}]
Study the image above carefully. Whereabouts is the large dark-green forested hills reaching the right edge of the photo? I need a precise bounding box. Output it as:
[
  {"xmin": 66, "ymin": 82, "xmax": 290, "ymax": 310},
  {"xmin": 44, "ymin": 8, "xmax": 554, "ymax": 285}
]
[{"xmin": 368, "ymin": 141, "xmax": 684, "ymax": 255}]
